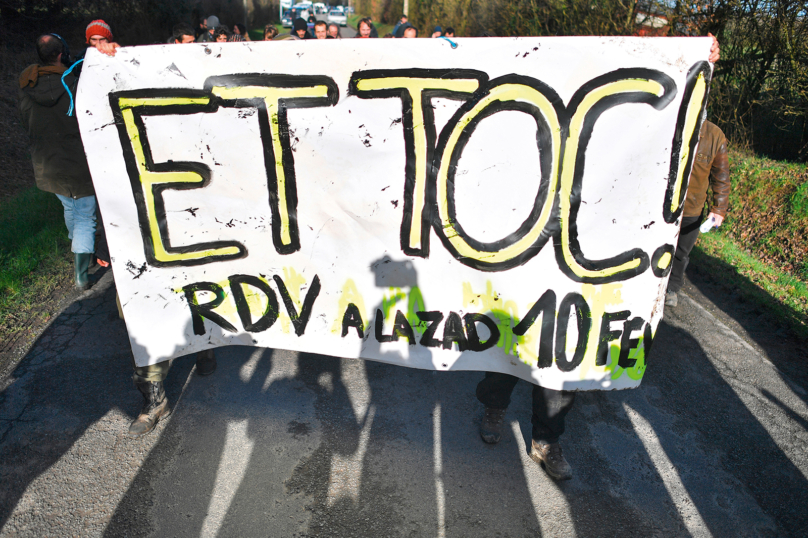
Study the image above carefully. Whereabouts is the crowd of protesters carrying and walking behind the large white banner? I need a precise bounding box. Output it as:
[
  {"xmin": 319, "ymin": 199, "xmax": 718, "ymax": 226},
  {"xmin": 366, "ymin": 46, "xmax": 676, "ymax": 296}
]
[{"xmin": 19, "ymin": 16, "xmax": 730, "ymax": 480}]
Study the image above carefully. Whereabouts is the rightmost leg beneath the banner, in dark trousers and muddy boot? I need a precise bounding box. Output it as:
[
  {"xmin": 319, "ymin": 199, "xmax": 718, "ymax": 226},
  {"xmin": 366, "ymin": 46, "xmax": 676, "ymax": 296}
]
[{"xmin": 530, "ymin": 386, "xmax": 575, "ymax": 480}]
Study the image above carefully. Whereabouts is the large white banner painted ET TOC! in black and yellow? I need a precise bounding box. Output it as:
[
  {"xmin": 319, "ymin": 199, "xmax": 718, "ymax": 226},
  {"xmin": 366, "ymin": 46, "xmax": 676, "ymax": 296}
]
[{"xmin": 76, "ymin": 37, "xmax": 711, "ymax": 390}]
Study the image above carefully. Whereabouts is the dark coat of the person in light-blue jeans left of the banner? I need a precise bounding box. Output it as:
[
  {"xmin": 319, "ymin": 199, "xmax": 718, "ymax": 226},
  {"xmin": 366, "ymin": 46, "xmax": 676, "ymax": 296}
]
[{"xmin": 20, "ymin": 65, "xmax": 95, "ymax": 198}]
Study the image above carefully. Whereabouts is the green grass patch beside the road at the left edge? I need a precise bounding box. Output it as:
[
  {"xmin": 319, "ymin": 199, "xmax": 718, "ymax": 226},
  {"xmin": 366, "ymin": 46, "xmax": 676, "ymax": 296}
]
[{"xmin": 0, "ymin": 187, "xmax": 73, "ymax": 342}]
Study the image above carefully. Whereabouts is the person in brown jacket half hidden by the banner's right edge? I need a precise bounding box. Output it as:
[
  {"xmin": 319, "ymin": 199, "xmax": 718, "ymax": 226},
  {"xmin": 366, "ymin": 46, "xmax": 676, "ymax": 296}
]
[{"xmin": 665, "ymin": 120, "xmax": 730, "ymax": 306}]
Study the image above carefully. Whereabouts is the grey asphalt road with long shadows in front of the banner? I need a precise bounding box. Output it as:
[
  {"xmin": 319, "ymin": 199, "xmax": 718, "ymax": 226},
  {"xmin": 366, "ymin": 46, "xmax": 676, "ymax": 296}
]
[{"xmin": 0, "ymin": 273, "xmax": 808, "ymax": 537}]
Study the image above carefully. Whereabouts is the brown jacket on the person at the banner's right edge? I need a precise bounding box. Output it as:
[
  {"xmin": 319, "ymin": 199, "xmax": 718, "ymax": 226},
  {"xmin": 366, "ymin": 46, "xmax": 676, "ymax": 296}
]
[{"xmin": 683, "ymin": 121, "xmax": 730, "ymax": 217}]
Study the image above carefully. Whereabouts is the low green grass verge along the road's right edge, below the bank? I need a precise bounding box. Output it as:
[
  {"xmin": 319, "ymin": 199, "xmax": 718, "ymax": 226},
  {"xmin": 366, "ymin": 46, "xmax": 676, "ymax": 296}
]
[{"xmin": 691, "ymin": 226, "xmax": 808, "ymax": 340}]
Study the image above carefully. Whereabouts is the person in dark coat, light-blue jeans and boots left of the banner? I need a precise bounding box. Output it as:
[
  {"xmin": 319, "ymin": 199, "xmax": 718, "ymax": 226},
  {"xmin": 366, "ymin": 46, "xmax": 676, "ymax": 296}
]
[{"xmin": 19, "ymin": 33, "xmax": 98, "ymax": 290}]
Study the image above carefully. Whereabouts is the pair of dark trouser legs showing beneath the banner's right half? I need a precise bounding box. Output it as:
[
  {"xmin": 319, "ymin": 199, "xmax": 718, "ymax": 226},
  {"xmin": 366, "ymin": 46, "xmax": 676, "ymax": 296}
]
[{"xmin": 477, "ymin": 372, "xmax": 575, "ymax": 443}]
